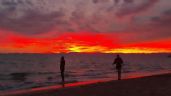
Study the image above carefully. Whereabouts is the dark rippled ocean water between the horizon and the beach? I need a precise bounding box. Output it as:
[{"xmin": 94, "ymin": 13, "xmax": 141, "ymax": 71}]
[{"xmin": 0, "ymin": 53, "xmax": 171, "ymax": 92}]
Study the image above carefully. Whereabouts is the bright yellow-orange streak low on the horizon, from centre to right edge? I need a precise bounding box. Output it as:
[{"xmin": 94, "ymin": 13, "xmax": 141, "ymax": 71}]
[{"xmin": 69, "ymin": 46, "xmax": 171, "ymax": 53}]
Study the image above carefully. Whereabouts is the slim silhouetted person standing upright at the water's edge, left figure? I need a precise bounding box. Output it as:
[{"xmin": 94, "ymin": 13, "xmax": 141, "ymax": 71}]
[{"xmin": 60, "ymin": 56, "xmax": 65, "ymax": 86}]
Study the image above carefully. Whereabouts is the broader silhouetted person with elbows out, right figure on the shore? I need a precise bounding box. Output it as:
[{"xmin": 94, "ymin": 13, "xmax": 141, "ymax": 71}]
[{"xmin": 113, "ymin": 55, "xmax": 123, "ymax": 80}]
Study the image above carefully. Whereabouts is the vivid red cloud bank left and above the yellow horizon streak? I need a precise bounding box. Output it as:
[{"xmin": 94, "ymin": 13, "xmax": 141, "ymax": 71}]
[{"xmin": 2, "ymin": 33, "xmax": 118, "ymax": 53}]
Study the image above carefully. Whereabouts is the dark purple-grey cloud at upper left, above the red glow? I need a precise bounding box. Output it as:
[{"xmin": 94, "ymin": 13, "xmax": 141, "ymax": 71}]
[{"xmin": 0, "ymin": 11, "xmax": 65, "ymax": 34}]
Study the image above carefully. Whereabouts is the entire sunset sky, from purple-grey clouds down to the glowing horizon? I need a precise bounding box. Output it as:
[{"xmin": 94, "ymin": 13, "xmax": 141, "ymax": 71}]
[{"xmin": 0, "ymin": 0, "xmax": 171, "ymax": 53}]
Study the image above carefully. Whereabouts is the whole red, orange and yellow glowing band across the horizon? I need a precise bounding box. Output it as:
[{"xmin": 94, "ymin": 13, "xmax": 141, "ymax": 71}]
[{"xmin": 0, "ymin": 33, "xmax": 171, "ymax": 53}]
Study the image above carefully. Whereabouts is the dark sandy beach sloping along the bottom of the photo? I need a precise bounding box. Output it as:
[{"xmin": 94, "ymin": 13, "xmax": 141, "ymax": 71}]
[{"xmin": 1, "ymin": 74, "xmax": 171, "ymax": 96}]
